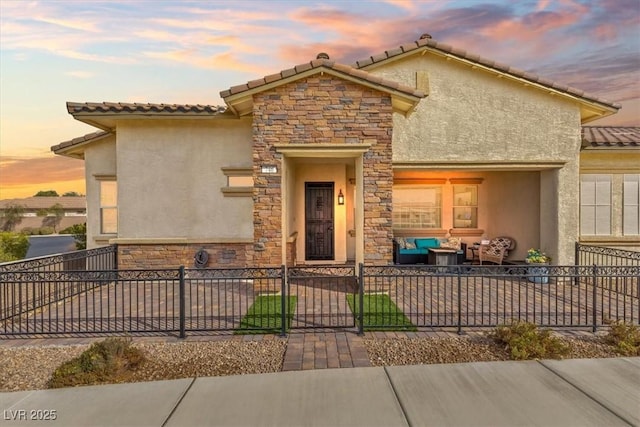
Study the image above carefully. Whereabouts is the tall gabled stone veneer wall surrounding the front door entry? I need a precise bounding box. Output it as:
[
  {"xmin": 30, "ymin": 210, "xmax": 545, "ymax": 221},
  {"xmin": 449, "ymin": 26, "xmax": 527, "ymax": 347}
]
[{"xmin": 253, "ymin": 74, "xmax": 393, "ymax": 266}]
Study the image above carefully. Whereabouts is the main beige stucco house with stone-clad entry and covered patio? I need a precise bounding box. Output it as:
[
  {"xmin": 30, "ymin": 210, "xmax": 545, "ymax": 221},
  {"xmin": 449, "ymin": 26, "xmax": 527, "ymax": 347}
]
[{"xmin": 52, "ymin": 34, "xmax": 620, "ymax": 268}]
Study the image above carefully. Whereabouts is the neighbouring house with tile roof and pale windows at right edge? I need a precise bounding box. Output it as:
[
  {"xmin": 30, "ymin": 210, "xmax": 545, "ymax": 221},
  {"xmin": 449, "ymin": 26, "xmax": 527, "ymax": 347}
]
[{"xmin": 580, "ymin": 126, "xmax": 640, "ymax": 251}]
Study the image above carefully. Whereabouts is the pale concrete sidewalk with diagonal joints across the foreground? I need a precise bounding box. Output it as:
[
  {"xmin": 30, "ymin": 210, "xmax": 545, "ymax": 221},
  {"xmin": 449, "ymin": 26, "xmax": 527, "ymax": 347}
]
[{"xmin": 0, "ymin": 357, "xmax": 640, "ymax": 427}]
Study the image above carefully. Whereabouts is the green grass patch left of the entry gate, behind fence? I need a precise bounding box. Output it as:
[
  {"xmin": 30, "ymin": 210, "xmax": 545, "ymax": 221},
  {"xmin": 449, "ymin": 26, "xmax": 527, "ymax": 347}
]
[{"xmin": 234, "ymin": 295, "xmax": 298, "ymax": 334}]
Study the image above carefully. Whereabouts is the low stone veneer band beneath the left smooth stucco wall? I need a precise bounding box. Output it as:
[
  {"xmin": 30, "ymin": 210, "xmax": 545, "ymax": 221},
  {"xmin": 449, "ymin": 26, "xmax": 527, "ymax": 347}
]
[{"xmin": 118, "ymin": 243, "xmax": 253, "ymax": 270}]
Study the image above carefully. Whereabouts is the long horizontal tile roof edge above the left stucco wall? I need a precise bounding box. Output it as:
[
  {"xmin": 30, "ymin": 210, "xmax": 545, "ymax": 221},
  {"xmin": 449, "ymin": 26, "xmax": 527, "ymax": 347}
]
[{"xmin": 67, "ymin": 102, "xmax": 226, "ymax": 115}]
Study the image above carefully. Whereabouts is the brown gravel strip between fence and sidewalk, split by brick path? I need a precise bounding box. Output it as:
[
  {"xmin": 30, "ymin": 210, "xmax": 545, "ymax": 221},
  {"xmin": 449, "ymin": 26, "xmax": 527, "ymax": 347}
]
[{"xmin": 0, "ymin": 335, "xmax": 617, "ymax": 391}]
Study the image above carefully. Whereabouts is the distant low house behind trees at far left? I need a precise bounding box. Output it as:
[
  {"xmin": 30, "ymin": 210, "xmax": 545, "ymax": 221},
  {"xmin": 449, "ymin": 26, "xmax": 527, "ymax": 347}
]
[{"xmin": 0, "ymin": 196, "xmax": 87, "ymax": 232}]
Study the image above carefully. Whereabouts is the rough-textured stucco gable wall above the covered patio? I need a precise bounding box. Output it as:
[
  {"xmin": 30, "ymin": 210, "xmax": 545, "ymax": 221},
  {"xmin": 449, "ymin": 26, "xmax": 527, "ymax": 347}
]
[{"xmin": 368, "ymin": 54, "xmax": 580, "ymax": 162}]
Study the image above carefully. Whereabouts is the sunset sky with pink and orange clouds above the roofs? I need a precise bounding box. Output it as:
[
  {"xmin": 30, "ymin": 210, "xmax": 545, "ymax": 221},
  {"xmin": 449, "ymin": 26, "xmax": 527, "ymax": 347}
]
[{"xmin": 0, "ymin": 0, "xmax": 640, "ymax": 199}]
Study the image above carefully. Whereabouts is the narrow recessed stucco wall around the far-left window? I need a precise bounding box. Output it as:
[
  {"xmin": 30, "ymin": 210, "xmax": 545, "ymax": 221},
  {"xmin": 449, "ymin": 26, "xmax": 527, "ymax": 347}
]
[{"xmin": 84, "ymin": 135, "xmax": 117, "ymax": 249}]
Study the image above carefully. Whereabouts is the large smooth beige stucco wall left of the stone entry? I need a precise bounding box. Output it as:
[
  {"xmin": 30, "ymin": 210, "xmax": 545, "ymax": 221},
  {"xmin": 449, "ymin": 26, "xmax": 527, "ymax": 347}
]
[{"xmin": 117, "ymin": 119, "xmax": 253, "ymax": 240}]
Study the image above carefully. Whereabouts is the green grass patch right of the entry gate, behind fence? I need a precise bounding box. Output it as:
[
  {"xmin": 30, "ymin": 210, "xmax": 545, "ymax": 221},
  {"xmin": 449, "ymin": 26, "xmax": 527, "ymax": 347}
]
[{"xmin": 347, "ymin": 294, "xmax": 417, "ymax": 331}]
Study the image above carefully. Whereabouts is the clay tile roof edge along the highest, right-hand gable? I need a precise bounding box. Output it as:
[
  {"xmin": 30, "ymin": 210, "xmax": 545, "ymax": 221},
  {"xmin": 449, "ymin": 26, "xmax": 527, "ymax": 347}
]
[{"xmin": 353, "ymin": 37, "xmax": 620, "ymax": 109}]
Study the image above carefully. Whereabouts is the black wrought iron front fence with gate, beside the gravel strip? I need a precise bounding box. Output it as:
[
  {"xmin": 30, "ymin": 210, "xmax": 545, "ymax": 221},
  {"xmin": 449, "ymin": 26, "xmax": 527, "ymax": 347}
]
[{"xmin": 0, "ymin": 265, "xmax": 640, "ymax": 337}]
